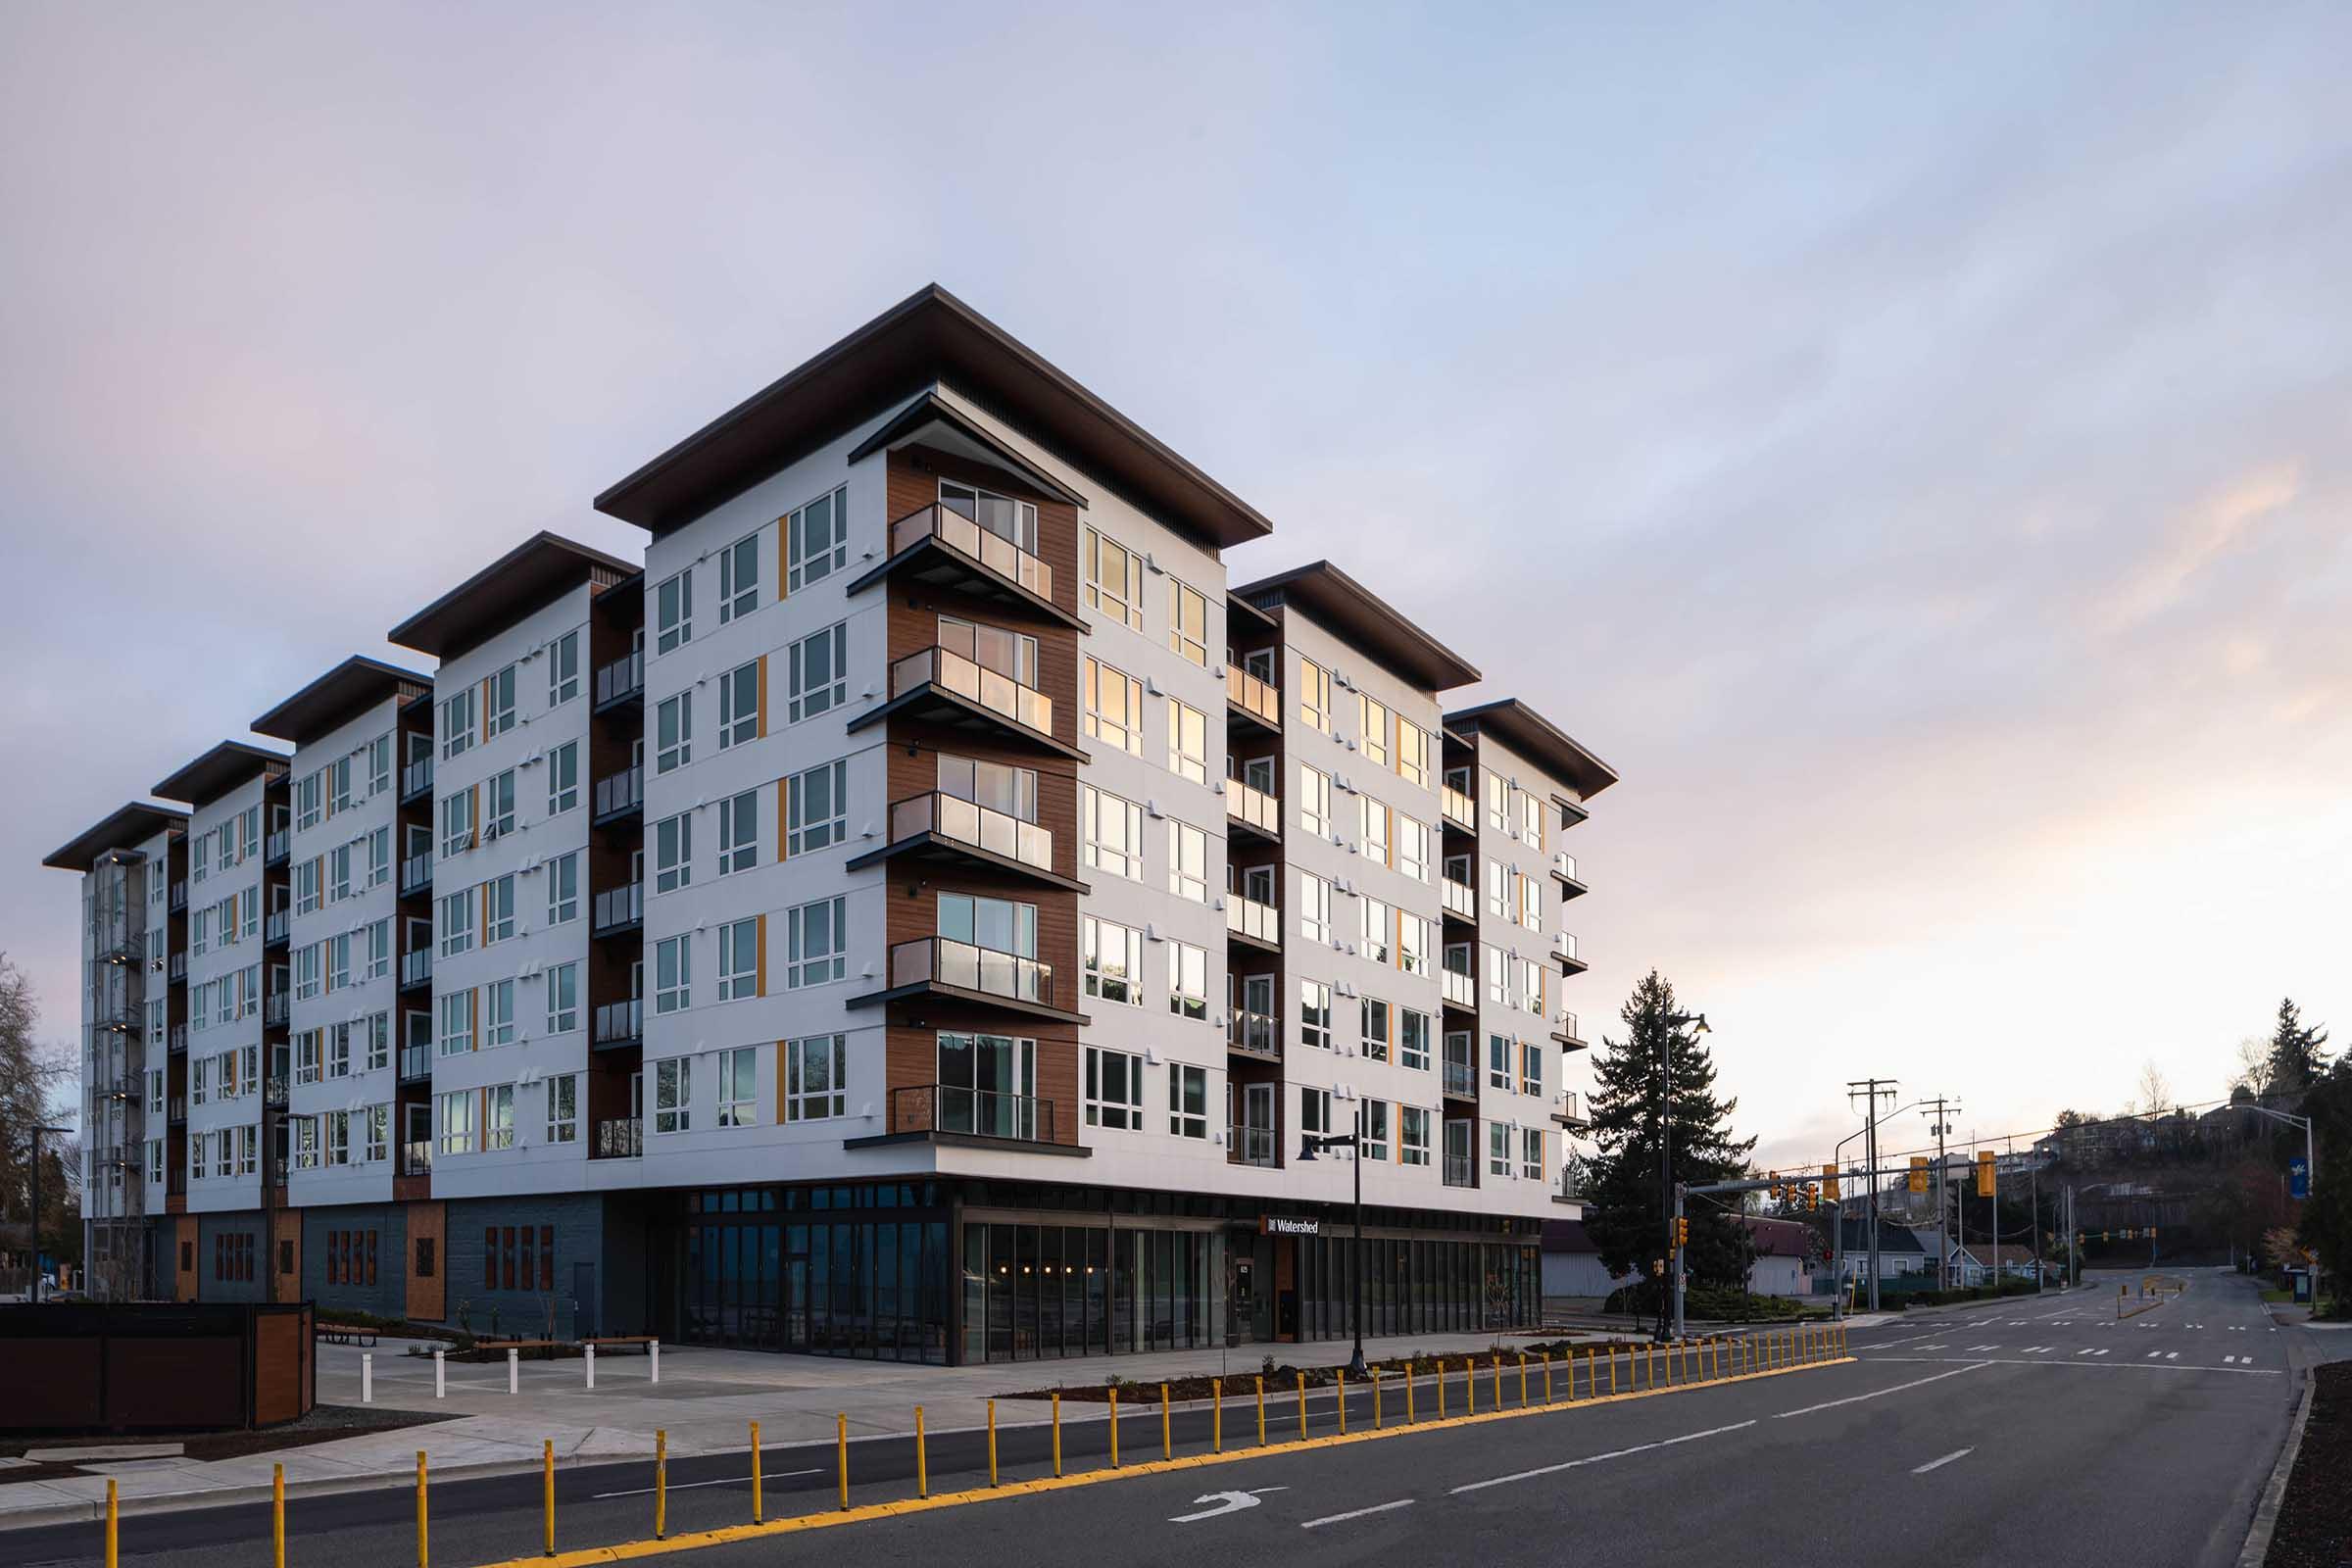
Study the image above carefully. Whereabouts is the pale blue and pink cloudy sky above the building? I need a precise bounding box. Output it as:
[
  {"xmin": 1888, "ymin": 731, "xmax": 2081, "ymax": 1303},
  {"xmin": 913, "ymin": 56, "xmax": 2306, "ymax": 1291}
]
[{"xmin": 0, "ymin": 0, "xmax": 2352, "ymax": 1163}]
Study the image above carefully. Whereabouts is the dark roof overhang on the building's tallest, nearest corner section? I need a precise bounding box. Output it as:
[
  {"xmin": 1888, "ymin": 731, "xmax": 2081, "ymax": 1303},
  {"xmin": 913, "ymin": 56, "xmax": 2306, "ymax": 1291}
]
[{"xmin": 595, "ymin": 284, "xmax": 1275, "ymax": 548}]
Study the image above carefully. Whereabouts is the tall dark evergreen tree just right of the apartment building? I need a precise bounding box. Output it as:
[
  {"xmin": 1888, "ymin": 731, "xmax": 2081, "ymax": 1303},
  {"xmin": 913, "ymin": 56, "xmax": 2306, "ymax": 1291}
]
[{"xmin": 1586, "ymin": 968, "xmax": 1754, "ymax": 1307}]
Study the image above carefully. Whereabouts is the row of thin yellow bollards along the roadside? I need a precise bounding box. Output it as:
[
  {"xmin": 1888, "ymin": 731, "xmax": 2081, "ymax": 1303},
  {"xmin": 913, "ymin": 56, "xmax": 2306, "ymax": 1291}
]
[{"xmin": 171, "ymin": 1324, "xmax": 1846, "ymax": 1568}]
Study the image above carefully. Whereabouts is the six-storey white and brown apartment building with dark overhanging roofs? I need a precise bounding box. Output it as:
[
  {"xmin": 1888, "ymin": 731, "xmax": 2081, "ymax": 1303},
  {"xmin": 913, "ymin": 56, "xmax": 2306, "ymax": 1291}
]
[{"xmin": 52, "ymin": 289, "xmax": 1613, "ymax": 1361}]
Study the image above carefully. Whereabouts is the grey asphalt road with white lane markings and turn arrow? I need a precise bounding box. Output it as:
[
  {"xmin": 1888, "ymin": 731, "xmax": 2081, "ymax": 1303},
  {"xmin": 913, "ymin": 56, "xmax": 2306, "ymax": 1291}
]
[{"xmin": 0, "ymin": 1274, "xmax": 2293, "ymax": 1568}]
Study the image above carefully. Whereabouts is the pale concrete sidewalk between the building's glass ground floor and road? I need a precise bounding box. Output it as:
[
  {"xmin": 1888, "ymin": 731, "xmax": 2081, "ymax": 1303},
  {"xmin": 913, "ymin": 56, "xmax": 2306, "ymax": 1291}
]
[{"xmin": 0, "ymin": 1333, "xmax": 1609, "ymax": 1531}]
